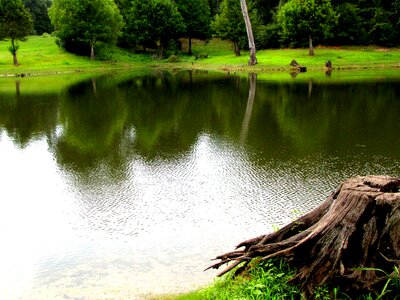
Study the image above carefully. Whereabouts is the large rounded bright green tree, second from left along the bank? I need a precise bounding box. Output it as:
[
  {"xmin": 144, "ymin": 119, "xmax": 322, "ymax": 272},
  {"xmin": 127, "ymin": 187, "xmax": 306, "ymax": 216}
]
[{"xmin": 49, "ymin": 0, "xmax": 124, "ymax": 59}]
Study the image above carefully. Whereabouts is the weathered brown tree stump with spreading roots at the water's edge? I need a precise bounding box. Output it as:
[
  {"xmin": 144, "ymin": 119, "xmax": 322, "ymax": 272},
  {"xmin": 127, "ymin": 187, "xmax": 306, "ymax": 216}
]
[{"xmin": 209, "ymin": 176, "xmax": 400, "ymax": 298}]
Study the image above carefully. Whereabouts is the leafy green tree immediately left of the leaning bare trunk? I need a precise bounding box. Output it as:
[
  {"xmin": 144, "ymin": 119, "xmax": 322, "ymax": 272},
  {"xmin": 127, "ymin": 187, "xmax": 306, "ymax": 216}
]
[{"xmin": 211, "ymin": 0, "xmax": 247, "ymax": 56}]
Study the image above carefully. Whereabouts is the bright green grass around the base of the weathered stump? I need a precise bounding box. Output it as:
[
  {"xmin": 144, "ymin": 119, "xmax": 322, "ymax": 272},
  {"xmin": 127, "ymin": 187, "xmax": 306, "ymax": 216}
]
[{"xmin": 150, "ymin": 259, "xmax": 400, "ymax": 300}]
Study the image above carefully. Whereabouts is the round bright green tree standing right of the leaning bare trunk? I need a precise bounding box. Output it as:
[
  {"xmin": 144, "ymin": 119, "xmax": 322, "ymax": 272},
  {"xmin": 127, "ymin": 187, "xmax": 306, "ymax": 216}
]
[{"xmin": 278, "ymin": 0, "xmax": 337, "ymax": 56}]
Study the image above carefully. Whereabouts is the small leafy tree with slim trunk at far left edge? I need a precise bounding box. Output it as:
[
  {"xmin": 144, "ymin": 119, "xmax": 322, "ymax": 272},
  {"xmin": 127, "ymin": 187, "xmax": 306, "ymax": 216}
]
[{"xmin": 0, "ymin": 0, "xmax": 33, "ymax": 66}]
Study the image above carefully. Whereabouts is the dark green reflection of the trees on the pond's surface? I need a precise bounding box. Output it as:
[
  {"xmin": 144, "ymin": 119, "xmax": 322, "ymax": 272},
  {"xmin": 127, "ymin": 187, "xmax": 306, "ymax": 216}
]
[{"xmin": 0, "ymin": 71, "xmax": 400, "ymax": 183}]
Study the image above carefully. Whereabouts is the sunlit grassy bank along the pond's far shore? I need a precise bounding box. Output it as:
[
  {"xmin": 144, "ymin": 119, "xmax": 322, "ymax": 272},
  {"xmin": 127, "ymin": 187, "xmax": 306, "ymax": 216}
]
[{"xmin": 0, "ymin": 35, "xmax": 400, "ymax": 75}]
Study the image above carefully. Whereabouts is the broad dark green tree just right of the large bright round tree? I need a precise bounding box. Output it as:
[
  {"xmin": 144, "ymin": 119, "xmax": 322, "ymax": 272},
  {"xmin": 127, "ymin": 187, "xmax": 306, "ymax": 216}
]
[{"xmin": 126, "ymin": 0, "xmax": 185, "ymax": 56}]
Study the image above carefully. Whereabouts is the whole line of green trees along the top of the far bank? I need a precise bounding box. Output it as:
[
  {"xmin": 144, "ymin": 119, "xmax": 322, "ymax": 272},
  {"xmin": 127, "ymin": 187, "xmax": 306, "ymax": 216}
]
[{"xmin": 0, "ymin": 0, "xmax": 400, "ymax": 60}]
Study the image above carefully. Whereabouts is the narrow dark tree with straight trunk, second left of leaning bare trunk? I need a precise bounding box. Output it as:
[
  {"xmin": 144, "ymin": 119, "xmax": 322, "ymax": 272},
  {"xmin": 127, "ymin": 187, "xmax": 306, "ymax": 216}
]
[{"xmin": 175, "ymin": 0, "xmax": 211, "ymax": 55}]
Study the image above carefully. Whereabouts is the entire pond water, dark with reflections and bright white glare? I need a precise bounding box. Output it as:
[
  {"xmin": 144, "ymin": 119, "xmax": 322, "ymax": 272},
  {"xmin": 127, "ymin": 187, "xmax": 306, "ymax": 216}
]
[{"xmin": 0, "ymin": 72, "xmax": 400, "ymax": 299}]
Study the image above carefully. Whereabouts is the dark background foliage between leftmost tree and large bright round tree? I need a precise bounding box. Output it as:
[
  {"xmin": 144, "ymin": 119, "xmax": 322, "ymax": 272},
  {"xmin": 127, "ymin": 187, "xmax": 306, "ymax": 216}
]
[{"xmin": 23, "ymin": 0, "xmax": 53, "ymax": 35}]
